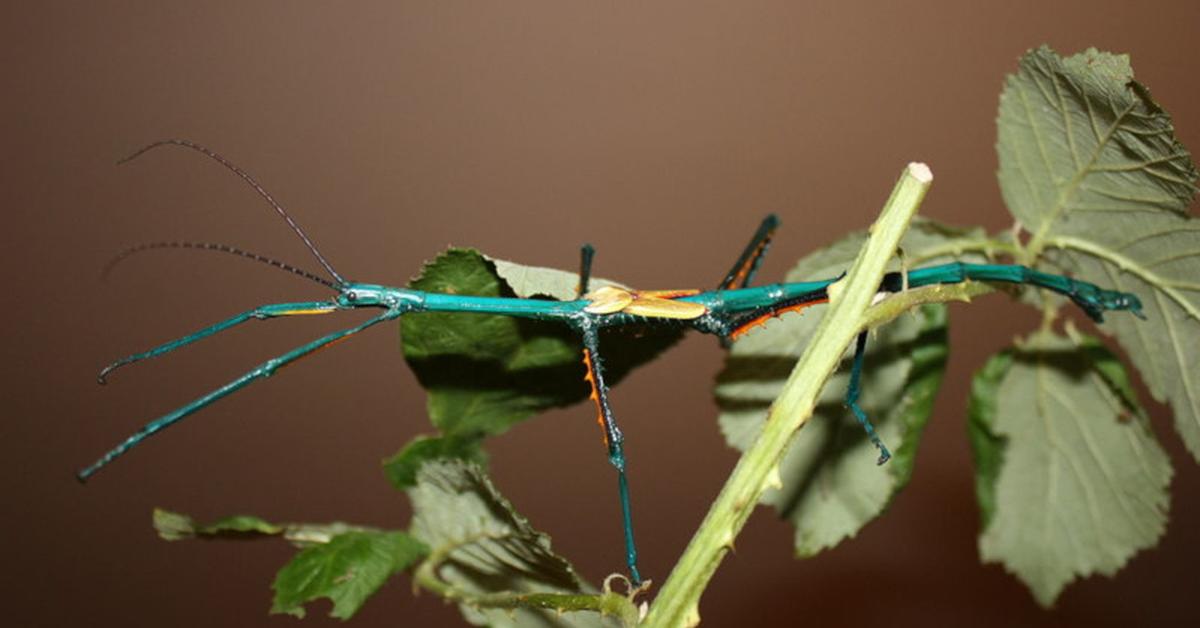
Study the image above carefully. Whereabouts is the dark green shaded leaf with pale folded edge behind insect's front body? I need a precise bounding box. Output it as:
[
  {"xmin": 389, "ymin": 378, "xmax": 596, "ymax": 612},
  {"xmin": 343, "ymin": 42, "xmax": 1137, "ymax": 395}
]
[{"xmin": 389, "ymin": 249, "xmax": 682, "ymax": 468}]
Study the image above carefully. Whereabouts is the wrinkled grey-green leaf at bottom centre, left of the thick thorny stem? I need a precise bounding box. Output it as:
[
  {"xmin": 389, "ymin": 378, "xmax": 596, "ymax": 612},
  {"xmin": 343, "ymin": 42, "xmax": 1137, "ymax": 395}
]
[{"xmin": 409, "ymin": 460, "xmax": 607, "ymax": 627}]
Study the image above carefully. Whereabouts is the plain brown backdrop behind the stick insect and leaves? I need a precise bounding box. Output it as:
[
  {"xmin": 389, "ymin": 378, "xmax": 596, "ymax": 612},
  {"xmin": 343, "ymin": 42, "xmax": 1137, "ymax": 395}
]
[{"xmin": 0, "ymin": 1, "xmax": 1200, "ymax": 627}]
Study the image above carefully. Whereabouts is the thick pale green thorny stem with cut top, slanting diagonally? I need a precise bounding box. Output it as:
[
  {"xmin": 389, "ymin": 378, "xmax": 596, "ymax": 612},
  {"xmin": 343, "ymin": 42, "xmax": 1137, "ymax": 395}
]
[{"xmin": 646, "ymin": 163, "xmax": 932, "ymax": 627}]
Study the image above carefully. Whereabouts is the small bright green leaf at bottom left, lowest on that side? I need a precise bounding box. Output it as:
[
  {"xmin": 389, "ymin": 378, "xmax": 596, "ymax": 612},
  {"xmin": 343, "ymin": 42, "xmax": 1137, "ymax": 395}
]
[{"xmin": 271, "ymin": 532, "xmax": 428, "ymax": 620}]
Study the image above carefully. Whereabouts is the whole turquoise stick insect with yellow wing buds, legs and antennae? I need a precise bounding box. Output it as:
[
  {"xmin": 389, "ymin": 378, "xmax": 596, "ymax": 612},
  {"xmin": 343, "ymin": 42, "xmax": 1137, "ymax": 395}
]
[{"xmin": 78, "ymin": 139, "xmax": 1141, "ymax": 585}]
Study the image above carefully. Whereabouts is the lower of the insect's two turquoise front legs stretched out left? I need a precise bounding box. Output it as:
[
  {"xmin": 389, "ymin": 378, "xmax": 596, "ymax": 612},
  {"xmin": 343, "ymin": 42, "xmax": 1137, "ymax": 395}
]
[{"xmin": 77, "ymin": 310, "xmax": 403, "ymax": 482}]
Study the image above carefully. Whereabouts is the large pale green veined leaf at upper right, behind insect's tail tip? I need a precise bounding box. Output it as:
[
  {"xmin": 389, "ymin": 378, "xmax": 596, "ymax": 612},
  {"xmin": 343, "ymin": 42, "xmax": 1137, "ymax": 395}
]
[{"xmin": 996, "ymin": 47, "xmax": 1200, "ymax": 460}]
